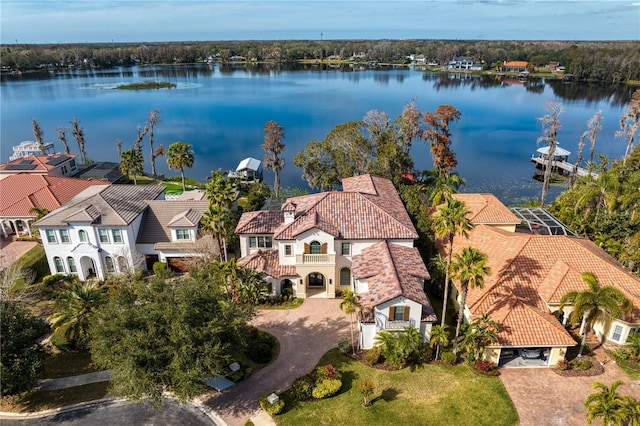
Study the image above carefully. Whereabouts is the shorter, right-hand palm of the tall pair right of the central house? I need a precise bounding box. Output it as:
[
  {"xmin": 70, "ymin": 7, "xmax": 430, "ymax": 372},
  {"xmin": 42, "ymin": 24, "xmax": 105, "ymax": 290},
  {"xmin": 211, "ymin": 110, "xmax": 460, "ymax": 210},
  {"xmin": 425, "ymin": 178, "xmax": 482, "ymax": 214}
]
[{"xmin": 451, "ymin": 247, "xmax": 491, "ymax": 352}]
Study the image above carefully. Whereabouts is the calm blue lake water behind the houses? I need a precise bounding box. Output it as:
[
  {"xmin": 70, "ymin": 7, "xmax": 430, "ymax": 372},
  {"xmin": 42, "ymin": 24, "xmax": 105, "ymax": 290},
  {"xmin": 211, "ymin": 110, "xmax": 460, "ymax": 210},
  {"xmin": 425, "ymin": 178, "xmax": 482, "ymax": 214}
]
[{"xmin": 0, "ymin": 64, "xmax": 633, "ymax": 203}]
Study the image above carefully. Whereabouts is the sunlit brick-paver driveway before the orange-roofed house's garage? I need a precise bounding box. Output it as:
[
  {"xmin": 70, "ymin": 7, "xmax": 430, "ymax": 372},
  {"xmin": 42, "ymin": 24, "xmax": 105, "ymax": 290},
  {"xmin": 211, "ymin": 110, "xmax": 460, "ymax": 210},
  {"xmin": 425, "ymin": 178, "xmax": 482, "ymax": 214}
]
[{"xmin": 500, "ymin": 362, "xmax": 640, "ymax": 426}]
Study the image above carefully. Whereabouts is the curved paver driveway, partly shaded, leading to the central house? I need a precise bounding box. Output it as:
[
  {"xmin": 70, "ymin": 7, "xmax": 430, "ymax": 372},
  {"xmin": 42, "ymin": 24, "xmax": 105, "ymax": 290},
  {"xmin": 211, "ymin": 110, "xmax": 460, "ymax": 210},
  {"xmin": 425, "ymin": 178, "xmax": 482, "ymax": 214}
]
[{"xmin": 202, "ymin": 298, "xmax": 350, "ymax": 426}]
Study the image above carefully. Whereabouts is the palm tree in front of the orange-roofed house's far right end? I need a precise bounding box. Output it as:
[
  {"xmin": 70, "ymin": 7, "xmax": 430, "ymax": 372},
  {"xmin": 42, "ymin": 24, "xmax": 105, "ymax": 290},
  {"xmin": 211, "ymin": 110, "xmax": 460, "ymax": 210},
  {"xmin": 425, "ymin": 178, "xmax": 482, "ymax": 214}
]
[{"xmin": 560, "ymin": 272, "xmax": 633, "ymax": 356}]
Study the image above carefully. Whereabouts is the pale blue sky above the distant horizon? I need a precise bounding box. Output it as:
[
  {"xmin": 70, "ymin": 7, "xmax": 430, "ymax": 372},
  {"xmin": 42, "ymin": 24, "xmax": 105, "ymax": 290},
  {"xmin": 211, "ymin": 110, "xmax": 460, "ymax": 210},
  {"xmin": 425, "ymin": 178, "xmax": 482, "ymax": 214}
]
[{"xmin": 0, "ymin": 0, "xmax": 640, "ymax": 44}]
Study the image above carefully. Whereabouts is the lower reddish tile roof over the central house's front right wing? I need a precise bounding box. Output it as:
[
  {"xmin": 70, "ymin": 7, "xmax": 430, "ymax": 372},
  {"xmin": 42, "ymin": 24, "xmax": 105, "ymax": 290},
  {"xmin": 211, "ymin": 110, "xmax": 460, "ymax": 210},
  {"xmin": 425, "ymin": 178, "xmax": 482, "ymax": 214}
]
[{"xmin": 352, "ymin": 241, "xmax": 436, "ymax": 321}]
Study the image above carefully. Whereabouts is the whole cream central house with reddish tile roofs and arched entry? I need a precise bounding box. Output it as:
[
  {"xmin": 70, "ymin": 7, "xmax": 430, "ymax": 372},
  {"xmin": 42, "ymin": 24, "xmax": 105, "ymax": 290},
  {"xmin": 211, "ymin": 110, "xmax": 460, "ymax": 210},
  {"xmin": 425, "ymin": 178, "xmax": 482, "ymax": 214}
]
[{"xmin": 236, "ymin": 175, "xmax": 435, "ymax": 347}]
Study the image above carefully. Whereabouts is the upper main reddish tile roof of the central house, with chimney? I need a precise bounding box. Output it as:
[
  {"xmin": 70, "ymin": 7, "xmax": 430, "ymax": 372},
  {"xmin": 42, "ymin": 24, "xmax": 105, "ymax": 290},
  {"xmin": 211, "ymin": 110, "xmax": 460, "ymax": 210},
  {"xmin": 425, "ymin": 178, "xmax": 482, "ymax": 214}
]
[{"xmin": 236, "ymin": 175, "xmax": 418, "ymax": 240}]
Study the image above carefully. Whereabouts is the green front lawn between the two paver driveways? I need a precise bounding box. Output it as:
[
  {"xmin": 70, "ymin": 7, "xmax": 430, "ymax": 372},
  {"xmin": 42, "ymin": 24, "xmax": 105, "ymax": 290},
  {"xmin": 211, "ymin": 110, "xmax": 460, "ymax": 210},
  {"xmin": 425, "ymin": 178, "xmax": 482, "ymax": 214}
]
[{"xmin": 275, "ymin": 349, "xmax": 518, "ymax": 426}]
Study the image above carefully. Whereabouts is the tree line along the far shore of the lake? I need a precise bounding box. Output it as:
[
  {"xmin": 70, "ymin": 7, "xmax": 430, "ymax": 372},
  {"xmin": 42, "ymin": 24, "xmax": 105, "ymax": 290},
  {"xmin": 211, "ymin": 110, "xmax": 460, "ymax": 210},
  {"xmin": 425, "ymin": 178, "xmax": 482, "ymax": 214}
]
[{"xmin": 0, "ymin": 40, "xmax": 640, "ymax": 84}]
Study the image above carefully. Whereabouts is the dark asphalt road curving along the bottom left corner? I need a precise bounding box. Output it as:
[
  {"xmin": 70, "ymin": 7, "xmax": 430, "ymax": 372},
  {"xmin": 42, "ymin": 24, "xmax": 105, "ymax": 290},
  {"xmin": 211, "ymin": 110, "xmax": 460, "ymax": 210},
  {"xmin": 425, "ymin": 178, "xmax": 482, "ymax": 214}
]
[{"xmin": 0, "ymin": 401, "xmax": 216, "ymax": 426}]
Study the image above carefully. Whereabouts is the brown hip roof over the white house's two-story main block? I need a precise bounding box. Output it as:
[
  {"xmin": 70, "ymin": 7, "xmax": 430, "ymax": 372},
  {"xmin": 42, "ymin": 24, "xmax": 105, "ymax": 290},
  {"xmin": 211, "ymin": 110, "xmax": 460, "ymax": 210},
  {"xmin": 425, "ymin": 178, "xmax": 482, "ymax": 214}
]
[{"xmin": 36, "ymin": 185, "xmax": 165, "ymax": 227}]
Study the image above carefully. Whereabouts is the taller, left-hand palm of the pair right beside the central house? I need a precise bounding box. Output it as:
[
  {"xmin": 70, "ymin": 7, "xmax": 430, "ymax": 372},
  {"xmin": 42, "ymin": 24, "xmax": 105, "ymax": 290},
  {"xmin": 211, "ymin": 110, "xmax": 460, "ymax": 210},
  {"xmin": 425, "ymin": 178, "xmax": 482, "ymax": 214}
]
[{"xmin": 433, "ymin": 198, "xmax": 473, "ymax": 325}]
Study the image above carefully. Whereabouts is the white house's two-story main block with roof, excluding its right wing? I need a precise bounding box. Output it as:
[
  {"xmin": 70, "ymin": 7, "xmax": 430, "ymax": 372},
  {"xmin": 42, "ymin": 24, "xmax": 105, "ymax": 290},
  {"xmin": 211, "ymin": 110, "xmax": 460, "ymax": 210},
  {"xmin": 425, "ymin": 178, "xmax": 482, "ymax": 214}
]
[{"xmin": 35, "ymin": 185, "xmax": 164, "ymax": 281}]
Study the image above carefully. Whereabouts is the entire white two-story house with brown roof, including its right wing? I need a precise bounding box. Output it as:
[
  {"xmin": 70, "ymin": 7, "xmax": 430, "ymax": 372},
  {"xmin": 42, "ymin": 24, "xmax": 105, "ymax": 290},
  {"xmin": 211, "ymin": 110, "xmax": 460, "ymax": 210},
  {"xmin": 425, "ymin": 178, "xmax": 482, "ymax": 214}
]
[{"xmin": 35, "ymin": 185, "xmax": 208, "ymax": 281}]
